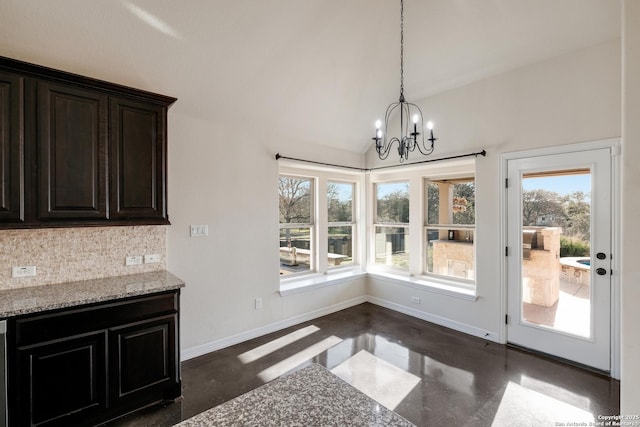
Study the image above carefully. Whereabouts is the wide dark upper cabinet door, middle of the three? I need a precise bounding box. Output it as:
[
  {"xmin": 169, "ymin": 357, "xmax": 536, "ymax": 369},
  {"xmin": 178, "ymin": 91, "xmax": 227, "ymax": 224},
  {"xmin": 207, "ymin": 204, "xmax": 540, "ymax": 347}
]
[{"xmin": 36, "ymin": 81, "xmax": 107, "ymax": 220}]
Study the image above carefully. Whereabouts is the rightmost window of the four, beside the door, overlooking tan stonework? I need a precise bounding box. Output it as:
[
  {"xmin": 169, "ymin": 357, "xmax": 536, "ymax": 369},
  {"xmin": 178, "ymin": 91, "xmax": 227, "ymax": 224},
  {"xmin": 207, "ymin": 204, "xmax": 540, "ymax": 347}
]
[{"xmin": 425, "ymin": 178, "xmax": 475, "ymax": 281}]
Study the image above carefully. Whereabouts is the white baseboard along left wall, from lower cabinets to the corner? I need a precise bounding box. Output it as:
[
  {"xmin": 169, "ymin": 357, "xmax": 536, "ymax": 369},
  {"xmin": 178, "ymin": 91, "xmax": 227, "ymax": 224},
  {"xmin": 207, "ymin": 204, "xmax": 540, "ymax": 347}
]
[{"xmin": 180, "ymin": 296, "xmax": 368, "ymax": 361}]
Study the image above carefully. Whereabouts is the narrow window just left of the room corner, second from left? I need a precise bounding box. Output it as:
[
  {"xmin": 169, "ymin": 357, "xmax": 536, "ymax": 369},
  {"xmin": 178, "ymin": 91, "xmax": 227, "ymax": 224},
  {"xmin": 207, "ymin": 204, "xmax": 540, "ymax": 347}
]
[{"xmin": 327, "ymin": 181, "xmax": 355, "ymax": 268}]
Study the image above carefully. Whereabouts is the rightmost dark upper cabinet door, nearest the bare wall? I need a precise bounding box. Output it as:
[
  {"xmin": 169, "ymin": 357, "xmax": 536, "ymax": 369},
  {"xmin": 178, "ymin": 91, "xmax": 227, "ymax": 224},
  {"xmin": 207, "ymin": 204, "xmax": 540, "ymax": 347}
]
[{"xmin": 110, "ymin": 98, "xmax": 168, "ymax": 223}]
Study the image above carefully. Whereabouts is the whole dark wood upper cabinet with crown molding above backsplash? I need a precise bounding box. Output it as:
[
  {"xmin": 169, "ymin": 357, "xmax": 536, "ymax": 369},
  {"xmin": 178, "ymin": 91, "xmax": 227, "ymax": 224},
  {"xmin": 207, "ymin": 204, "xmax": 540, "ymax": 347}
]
[{"xmin": 0, "ymin": 57, "xmax": 176, "ymax": 228}]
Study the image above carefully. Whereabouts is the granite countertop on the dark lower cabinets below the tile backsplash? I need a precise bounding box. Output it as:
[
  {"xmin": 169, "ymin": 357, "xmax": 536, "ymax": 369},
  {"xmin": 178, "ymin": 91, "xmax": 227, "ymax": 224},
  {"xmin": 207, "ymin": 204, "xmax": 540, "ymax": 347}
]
[{"xmin": 0, "ymin": 271, "xmax": 185, "ymax": 319}]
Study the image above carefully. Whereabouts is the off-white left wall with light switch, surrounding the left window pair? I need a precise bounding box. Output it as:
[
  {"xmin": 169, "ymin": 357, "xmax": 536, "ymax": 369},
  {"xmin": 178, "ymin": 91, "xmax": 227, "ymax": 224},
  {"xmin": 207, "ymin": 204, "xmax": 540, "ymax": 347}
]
[{"xmin": 167, "ymin": 110, "xmax": 366, "ymax": 356}]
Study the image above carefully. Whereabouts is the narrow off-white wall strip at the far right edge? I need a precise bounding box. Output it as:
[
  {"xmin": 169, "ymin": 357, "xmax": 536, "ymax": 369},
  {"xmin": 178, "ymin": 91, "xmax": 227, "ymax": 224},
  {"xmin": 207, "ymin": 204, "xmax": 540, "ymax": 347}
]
[{"xmin": 620, "ymin": 0, "xmax": 640, "ymax": 414}]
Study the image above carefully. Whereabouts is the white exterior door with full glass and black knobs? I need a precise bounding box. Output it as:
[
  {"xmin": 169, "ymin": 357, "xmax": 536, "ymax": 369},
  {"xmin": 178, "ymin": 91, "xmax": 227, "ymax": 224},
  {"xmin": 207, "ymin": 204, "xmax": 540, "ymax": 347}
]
[{"xmin": 507, "ymin": 148, "xmax": 612, "ymax": 371}]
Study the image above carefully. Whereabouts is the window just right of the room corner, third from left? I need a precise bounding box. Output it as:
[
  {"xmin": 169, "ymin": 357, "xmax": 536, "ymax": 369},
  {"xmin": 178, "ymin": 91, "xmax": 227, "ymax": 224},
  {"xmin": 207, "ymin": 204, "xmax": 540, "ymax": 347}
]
[{"xmin": 374, "ymin": 182, "xmax": 409, "ymax": 270}]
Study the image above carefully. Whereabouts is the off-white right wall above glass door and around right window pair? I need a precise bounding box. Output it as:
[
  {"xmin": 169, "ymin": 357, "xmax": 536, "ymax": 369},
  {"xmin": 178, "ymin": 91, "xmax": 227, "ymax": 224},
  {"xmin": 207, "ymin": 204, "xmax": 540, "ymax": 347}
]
[{"xmin": 368, "ymin": 40, "xmax": 621, "ymax": 337}]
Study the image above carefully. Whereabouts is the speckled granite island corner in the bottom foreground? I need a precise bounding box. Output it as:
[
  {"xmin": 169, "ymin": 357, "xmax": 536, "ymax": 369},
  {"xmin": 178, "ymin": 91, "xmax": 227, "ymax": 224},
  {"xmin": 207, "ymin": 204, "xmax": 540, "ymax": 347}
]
[{"xmin": 177, "ymin": 364, "xmax": 414, "ymax": 427}]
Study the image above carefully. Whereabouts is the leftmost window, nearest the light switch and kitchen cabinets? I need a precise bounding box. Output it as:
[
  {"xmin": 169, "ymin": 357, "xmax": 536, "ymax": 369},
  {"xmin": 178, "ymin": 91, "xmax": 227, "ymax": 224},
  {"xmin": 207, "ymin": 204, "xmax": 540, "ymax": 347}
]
[{"xmin": 278, "ymin": 175, "xmax": 314, "ymax": 276}]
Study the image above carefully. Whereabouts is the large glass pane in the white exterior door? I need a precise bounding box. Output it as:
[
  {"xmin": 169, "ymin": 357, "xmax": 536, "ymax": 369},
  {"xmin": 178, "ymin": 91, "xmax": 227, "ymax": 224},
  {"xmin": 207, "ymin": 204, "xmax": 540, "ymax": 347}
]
[{"xmin": 522, "ymin": 170, "xmax": 591, "ymax": 337}]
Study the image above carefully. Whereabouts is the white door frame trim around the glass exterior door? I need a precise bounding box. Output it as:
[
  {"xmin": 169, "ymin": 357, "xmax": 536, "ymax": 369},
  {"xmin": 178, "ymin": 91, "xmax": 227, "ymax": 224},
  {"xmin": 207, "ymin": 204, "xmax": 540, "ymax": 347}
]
[{"xmin": 499, "ymin": 138, "xmax": 621, "ymax": 379}]
